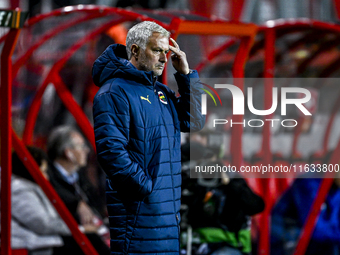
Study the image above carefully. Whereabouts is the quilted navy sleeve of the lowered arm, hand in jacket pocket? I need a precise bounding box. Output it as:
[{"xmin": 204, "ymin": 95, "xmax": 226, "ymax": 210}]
[{"xmin": 93, "ymin": 92, "xmax": 152, "ymax": 200}]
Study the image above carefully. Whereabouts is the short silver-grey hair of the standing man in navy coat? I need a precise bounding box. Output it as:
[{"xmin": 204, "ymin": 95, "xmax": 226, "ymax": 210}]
[{"xmin": 126, "ymin": 21, "xmax": 170, "ymax": 60}]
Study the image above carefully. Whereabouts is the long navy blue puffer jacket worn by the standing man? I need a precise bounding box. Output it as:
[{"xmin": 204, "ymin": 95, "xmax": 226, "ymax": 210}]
[{"xmin": 93, "ymin": 44, "xmax": 205, "ymax": 255}]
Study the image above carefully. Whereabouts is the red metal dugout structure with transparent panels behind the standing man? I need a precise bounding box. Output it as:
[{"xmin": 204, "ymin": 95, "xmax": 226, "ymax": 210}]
[{"xmin": 0, "ymin": 5, "xmax": 340, "ymax": 254}]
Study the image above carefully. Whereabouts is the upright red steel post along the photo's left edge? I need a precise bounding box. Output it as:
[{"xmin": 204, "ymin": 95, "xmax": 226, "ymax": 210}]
[{"xmin": 0, "ymin": 29, "xmax": 20, "ymax": 255}]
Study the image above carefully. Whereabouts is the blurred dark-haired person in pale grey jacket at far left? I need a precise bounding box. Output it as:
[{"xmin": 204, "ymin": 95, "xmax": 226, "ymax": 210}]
[{"xmin": 11, "ymin": 147, "xmax": 70, "ymax": 255}]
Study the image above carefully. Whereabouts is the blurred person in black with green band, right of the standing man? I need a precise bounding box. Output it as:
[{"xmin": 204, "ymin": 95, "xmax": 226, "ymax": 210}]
[{"xmin": 182, "ymin": 137, "xmax": 265, "ymax": 255}]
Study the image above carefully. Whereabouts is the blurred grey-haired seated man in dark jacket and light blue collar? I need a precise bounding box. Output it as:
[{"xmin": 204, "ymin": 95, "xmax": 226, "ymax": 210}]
[{"xmin": 47, "ymin": 126, "xmax": 109, "ymax": 254}]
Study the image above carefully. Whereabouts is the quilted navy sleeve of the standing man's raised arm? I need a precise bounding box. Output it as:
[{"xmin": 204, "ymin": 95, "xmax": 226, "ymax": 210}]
[{"xmin": 175, "ymin": 70, "xmax": 205, "ymax": 132}]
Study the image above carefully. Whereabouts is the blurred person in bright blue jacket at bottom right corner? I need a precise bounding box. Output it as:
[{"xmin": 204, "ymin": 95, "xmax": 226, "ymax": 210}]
[{"xmin": 270, "ymin": 151, "xmax": 340, "ymax": 255}]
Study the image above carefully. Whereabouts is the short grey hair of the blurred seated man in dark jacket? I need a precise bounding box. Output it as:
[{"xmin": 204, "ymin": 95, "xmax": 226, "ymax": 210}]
[{"xmin": 47, "ymin": 126, "xmax": 78, "ymax": 161}]
